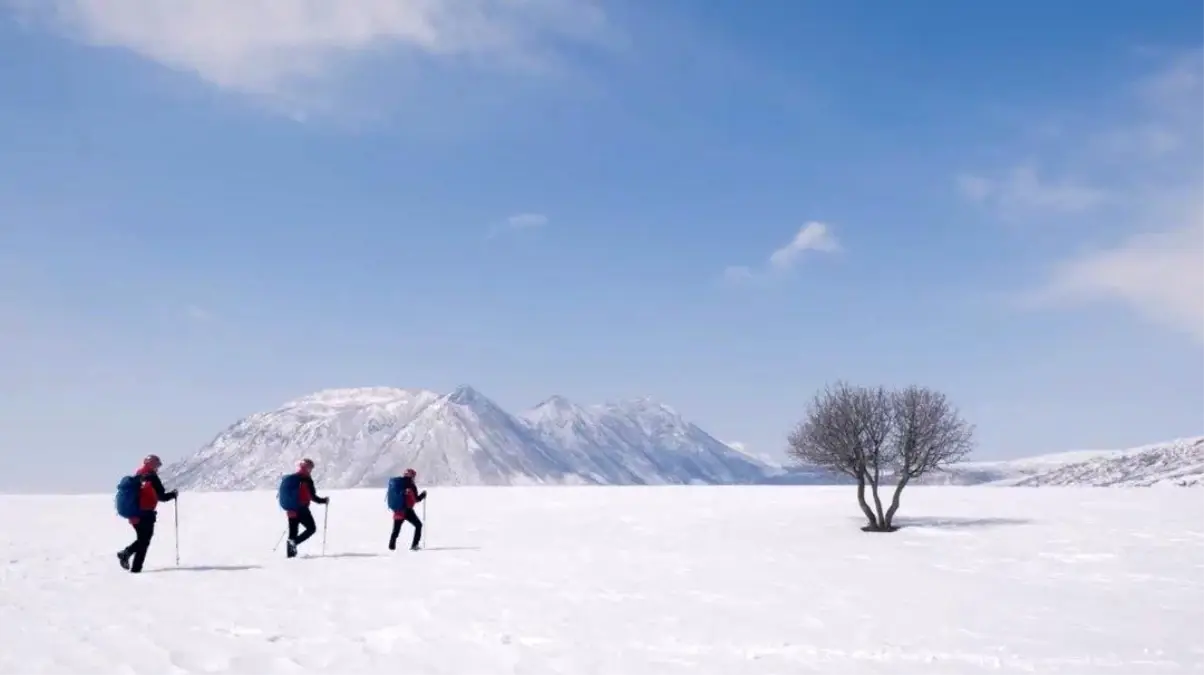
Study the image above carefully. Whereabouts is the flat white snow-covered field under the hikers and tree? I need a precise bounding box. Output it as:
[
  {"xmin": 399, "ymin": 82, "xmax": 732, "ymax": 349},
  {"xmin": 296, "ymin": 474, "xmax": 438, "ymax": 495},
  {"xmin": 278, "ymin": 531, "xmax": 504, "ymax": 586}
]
[{"xmin": 0, "ymin": 484, "xmax": 1204, "ymax": 675}]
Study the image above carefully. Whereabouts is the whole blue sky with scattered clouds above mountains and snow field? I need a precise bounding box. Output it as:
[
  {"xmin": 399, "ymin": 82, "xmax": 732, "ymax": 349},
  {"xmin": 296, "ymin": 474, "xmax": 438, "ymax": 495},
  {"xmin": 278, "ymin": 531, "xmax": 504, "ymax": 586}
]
[{"xmin": 0, "ymin": 0, "xmax": 1204, "ymax": 490}]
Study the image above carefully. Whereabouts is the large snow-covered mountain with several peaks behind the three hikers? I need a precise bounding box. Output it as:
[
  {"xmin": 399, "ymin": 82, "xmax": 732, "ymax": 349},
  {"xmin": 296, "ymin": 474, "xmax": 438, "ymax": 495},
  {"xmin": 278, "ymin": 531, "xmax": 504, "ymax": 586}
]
[{"xmin": 163, "ymin": 386, "xmax": 768, "ymax": 490}]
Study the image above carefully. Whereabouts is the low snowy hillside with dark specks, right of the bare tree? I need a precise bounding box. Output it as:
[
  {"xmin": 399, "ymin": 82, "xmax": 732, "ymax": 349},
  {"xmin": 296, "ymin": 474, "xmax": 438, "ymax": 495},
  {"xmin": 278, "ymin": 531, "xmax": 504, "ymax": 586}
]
[{"xmin": 923, "ymin": 437, "xmax": 1204, "ymax": 487}]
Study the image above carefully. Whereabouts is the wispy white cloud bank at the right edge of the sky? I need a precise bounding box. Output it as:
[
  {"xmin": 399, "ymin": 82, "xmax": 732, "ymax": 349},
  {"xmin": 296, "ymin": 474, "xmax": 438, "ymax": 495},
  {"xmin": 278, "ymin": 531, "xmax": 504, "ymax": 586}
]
[{"xmin": 961, "ymin": 49, "xmax": 1204, "ymax": 343}]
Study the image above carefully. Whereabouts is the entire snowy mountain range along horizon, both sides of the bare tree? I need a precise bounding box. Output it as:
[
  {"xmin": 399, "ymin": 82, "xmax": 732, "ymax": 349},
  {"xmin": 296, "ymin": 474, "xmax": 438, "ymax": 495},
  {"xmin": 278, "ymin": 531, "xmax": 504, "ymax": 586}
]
[{"xmin": 164, "ymin": 385, "xmax": 1204, "ymax": 490}]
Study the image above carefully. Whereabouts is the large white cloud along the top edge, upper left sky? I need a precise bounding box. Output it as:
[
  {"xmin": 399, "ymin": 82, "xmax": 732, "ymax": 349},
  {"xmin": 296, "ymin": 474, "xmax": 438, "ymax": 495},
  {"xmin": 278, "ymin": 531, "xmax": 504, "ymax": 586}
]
[{"xmin": 7, "ymin": 0, "xmax": 609, "ymax": 110}]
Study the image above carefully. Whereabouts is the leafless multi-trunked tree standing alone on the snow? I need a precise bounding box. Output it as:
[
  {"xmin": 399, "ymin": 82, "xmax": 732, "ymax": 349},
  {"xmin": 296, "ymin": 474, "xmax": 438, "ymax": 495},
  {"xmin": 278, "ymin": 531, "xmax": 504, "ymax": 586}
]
[{"xmin": 789, "ymin": 383, "xmax": 973, "ymax": 532}]
